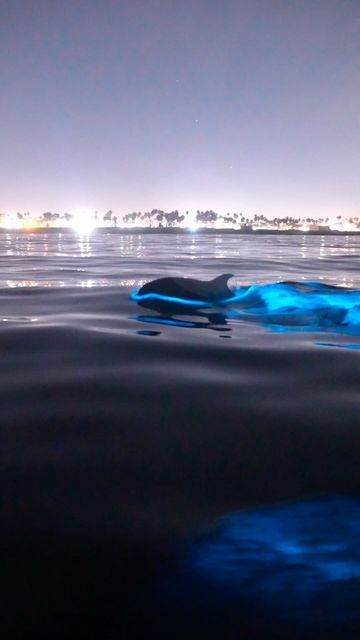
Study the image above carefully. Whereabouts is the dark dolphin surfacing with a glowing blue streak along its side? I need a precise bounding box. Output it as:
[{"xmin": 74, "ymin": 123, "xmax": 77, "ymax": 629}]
[{"xmin": 136, "ymin": 273, "xmax": 234, "ymax": 304}]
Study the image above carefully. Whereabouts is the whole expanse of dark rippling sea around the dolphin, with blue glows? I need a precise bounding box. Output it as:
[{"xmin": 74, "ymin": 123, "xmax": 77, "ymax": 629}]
[{"xmin": 0, "ymin": 232, "xmax": 360, "ymax": 640}]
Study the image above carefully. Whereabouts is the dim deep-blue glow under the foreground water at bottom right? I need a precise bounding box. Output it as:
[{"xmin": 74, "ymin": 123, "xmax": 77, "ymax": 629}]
[{"xmin": 191, "ymin": 499, "xmax": 360, "ymax": 592}]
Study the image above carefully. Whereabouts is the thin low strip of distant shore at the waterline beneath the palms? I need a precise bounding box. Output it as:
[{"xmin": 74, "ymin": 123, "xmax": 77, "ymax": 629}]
[{"xmin": 0, "ymin": 227, "xmax": 360, "ymax": 236}]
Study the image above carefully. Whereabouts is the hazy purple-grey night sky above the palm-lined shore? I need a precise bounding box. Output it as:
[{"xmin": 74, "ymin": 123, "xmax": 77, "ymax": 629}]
[{"xmin": 0, "ymin": 0, "xmax": 360, "ymax": 217}]
